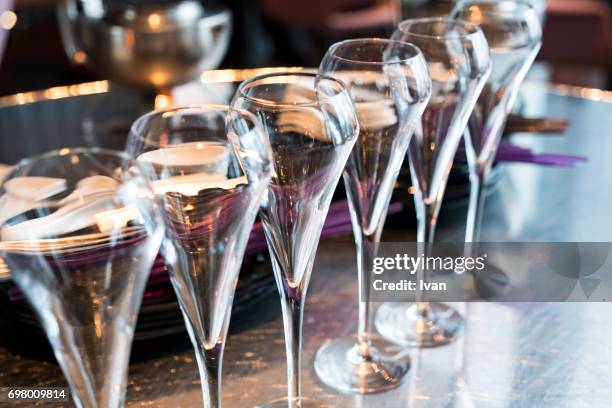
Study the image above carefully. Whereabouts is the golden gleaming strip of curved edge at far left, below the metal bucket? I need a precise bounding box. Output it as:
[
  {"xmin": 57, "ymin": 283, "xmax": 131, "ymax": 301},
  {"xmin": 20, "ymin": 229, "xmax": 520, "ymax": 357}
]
[{"xmin": 0, "ymin": 81, "xmax": 109, "ymax": 106}]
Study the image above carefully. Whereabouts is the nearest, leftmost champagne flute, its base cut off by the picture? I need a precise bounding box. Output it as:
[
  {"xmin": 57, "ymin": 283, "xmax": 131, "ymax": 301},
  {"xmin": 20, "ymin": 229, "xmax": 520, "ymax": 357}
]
[{"xmin": 0, "ymin": 149, "xmax": 163, "ymax": 408}]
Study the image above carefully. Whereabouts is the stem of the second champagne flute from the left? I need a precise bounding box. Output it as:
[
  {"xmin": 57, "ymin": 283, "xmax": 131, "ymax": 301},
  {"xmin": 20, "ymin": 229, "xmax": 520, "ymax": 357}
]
[{"xmin": 196, "ymin": 342, "xmax": 225, "ymax": 408}]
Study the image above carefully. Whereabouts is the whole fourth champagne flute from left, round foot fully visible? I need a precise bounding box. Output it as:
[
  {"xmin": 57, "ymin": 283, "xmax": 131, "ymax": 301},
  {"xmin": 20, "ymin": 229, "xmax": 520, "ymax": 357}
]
[{"xmin": 315, "ymin": 38, "xmax": 431, "ymax": 393}]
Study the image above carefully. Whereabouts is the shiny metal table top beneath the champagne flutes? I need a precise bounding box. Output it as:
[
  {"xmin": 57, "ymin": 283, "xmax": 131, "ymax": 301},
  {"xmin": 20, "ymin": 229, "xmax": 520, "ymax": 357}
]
[{"xmin": 0, "ymin": 83, "xmax": 612, "ymax": 408}]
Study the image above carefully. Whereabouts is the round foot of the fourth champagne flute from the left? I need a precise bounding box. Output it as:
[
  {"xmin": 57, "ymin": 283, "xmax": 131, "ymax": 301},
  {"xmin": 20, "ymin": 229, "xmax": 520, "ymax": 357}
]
[{"xmin": 314, "ymin": 336, "xmax": 410, "ymax": 394}]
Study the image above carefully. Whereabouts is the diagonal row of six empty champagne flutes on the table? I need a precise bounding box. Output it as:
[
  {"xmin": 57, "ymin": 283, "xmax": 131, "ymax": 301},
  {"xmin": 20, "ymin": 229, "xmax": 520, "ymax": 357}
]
[{"xmin": 0, "ymin": 1, "xmax": 539, "ymax": 407}]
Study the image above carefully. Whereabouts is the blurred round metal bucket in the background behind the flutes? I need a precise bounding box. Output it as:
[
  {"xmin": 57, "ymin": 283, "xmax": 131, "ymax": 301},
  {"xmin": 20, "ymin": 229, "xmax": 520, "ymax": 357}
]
[{"xmin": 58, "ymin": 0, "xmax": 232, "ymax": 89}]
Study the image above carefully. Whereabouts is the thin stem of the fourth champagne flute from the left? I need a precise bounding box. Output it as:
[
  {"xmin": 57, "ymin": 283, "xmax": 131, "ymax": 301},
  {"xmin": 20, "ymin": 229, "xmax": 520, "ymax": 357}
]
[{"xmin": 355, "ymin": 230, "xmax": 383, "ymax": 360}]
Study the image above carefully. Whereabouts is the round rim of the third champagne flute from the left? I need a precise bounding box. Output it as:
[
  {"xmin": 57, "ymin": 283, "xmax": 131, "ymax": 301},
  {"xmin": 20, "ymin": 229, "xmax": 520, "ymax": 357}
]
[{"xmin": 232, "ymin": 71, "xmax": 348, "ymax": 108}]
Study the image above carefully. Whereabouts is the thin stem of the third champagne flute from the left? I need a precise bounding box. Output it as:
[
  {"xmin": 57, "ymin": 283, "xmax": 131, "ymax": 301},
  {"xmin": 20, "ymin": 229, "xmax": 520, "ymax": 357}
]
[{"xmin": 282, "ymin": 287, "xmax": 305, "ymax": 408}]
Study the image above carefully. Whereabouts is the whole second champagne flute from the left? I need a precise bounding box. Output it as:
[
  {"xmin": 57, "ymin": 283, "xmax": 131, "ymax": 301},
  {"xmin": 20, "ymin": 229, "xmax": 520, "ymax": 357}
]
[{"xmin": 127, "ymin": 105, "xmax": 271, "ymax": 408}]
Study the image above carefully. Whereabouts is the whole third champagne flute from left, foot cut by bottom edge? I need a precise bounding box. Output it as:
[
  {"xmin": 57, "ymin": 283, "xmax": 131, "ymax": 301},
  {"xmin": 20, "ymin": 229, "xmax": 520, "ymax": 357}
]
[{"xmin": 232, "ymin": 73, "xmax": 359, "ymax": 408}]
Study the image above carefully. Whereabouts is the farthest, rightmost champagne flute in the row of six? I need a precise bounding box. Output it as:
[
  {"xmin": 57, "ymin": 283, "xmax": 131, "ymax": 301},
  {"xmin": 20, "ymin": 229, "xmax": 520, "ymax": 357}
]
[{"xmin": 451, "ymin": 0, "xmax": 542, "ymax": 242}]
